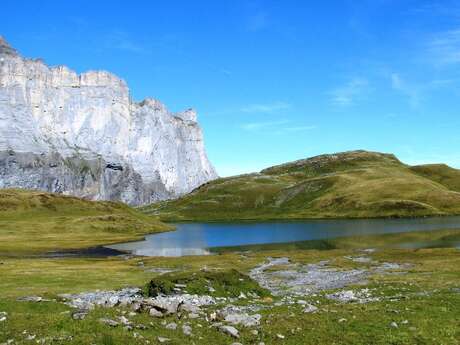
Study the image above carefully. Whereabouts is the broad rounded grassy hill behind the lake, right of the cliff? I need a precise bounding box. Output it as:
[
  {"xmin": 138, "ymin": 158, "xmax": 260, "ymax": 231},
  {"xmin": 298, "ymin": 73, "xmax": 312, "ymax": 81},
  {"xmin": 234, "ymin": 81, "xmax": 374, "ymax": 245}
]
[{"xmin": 141, "ymin": 151, "xmax": 460, "ymax": 221}]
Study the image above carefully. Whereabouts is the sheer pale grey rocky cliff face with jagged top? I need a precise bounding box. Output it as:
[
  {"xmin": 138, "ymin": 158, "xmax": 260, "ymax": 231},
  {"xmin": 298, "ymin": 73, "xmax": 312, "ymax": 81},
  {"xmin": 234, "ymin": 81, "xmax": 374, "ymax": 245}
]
[{"xmin": 0, "ymin": 37, "xmax": 217, "ymax": 205}]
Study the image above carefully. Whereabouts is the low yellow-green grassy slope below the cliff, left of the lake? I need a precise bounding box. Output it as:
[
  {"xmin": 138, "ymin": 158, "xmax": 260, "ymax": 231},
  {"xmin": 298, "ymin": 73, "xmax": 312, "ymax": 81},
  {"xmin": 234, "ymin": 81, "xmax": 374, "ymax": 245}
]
[{"xmin": 0, "ymin": 189, "xmax": 170, "ymax": 255}]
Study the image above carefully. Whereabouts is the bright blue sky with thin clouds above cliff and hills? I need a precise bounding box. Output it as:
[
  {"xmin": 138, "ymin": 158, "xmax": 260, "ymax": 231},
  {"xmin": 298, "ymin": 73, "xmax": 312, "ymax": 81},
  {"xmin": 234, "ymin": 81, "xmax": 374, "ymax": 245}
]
[{"xmin": 0, "ymin": 0, "xmax": 460, "ymax": 176}]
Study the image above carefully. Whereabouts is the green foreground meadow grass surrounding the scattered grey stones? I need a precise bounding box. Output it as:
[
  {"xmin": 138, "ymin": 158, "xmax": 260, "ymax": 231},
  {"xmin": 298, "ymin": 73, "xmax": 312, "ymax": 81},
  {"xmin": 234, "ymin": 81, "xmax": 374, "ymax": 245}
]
[{"xmin": 0, "ymin": 230, "xmax": 460, "ymax": 345}]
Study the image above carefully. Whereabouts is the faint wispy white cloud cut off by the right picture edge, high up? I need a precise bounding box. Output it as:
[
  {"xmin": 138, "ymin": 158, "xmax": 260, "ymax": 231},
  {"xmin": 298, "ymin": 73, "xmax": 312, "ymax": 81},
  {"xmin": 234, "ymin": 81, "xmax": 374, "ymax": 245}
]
[{"xmin": 428, "ymin": 28, "xmax": 460, "ymax": 66}]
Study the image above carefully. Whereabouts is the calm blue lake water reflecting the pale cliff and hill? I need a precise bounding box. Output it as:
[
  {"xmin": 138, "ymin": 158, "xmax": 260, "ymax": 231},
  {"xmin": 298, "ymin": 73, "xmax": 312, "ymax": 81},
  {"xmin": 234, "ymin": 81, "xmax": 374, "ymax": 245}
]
[{"xmin": 107, "ymin": 217, "xmax": 460, "ymax": 256}]
